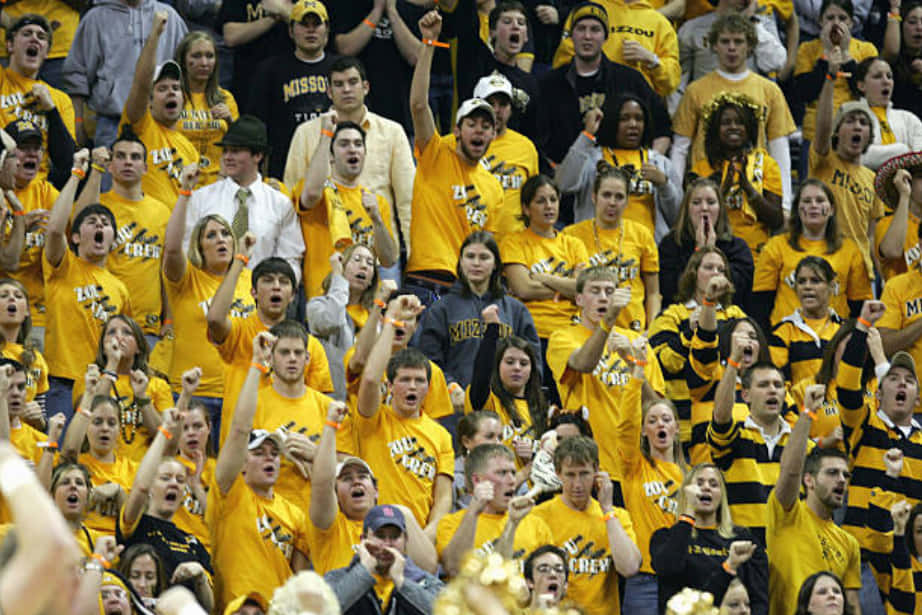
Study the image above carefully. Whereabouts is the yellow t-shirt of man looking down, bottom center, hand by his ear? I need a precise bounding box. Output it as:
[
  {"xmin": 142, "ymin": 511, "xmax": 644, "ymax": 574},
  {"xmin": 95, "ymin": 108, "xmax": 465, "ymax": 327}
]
[{"xmin": 529, "ymin": 496, "xmax": 637, "ymax": 615}]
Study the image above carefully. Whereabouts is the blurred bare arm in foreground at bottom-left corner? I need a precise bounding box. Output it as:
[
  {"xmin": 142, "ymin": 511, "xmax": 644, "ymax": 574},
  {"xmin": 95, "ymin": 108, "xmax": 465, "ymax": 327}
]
[{"xmin": 0, "ymin": 441, "xmax": 80, "ymax": 615}]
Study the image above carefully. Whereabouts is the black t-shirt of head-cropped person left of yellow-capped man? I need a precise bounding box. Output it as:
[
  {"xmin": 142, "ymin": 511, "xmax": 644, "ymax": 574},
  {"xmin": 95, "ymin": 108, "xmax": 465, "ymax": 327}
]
[{"xmin": 218, "ymin": 0, "xmax": 292, "ymax": 109}]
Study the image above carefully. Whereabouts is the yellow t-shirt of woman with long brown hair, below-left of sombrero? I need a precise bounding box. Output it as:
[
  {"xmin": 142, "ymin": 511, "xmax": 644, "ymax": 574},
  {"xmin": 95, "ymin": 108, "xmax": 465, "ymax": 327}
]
[{"xmin": 752, "ymin": 235, "xmax": 872, "ymax": 325}]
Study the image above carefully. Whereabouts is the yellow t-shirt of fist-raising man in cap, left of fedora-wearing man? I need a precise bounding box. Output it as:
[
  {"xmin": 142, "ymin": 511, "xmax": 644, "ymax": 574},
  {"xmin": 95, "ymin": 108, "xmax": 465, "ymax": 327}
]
[{"xmin": 119, "ymin": 109, "xmax": 199, "ymax": 211}]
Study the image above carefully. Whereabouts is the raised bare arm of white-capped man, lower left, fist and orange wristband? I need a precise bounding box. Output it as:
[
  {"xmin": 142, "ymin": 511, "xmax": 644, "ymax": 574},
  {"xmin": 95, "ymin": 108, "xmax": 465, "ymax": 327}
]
[{"xmin": 214, "ymin": 331, "xmax": 275, "ymax": 493}]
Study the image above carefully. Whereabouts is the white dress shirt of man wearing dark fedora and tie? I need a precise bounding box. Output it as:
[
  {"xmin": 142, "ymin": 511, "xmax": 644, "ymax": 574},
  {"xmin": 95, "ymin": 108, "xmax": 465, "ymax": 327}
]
[{"xmin": 183, "ymin": 174, "xmax": 304, "ymax": 280}]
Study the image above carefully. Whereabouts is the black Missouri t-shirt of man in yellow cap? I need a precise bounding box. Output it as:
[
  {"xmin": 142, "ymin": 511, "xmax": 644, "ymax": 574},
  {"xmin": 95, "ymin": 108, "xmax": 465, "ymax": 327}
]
[{"xmin": 249, "ymin": 53, "xmax": 336, "ymax": 179}]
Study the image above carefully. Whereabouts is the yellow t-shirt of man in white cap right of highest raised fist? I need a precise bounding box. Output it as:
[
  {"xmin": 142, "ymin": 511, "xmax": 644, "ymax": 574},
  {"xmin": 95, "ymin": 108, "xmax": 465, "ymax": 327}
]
[{"xmin": 445, "ymin": 128, "xmax": 538, "ymax": 242}]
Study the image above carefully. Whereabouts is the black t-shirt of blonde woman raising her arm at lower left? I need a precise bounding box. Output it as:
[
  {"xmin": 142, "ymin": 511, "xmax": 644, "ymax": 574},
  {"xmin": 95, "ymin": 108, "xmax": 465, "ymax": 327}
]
[{"xmin": 115, "ymin": 513, "xmax": 214, "ymax": 591}]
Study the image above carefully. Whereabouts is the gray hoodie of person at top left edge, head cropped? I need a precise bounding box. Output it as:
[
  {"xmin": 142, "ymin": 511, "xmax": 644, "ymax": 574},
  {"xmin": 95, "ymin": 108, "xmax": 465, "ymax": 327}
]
[{"xmin": 62, "ymin": 0, "xmax": 188, "ymax": 116}]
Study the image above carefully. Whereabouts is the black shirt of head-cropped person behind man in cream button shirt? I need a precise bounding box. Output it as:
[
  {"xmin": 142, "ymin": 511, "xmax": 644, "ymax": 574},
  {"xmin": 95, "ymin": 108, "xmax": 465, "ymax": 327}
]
[{"xmin": 330, "ymin": 0, "xmax": 426, "ymax": 132}]
